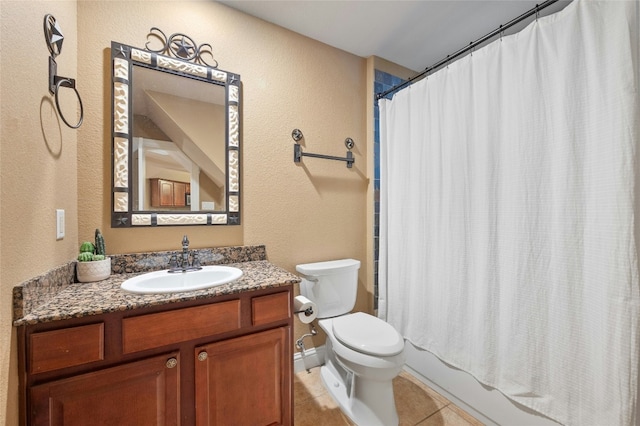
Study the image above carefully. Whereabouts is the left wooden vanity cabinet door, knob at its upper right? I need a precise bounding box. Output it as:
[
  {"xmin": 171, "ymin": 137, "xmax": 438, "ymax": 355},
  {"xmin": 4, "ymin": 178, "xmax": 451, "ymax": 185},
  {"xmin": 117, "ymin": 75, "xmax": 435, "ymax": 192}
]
[{"xmin": 29, "ymin": 353, "xmax": 180, "ymax": 426}]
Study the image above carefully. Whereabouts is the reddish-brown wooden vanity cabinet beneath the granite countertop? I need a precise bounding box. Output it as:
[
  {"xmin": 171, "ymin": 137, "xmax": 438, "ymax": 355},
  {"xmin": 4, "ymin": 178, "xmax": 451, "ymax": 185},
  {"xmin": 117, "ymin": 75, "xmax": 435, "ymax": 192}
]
[{"xmin": 18, "ymin": 285, "xmax": 293, "ymax": 425}]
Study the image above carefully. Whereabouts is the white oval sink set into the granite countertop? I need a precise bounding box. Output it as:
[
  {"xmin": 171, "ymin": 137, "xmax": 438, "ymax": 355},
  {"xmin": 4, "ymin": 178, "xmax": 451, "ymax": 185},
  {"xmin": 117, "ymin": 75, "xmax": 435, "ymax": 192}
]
[{"xmin": 120, "ymin": 265, "xmax": 242, "ymax": 294}]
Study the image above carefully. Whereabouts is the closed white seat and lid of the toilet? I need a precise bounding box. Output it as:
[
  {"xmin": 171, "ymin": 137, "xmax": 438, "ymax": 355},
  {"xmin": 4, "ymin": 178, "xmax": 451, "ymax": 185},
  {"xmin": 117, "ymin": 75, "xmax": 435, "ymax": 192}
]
[{"xmin": 332, "ymin": 312, "xmax": 404, "ymax": 356}]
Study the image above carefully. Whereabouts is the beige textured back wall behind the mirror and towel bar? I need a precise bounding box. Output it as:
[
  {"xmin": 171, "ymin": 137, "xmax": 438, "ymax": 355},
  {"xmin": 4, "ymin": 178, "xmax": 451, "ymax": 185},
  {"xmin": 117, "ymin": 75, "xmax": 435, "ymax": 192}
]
[{"xmin": 78, "ymin": 1, "xmax": 372, "ymax": 350}]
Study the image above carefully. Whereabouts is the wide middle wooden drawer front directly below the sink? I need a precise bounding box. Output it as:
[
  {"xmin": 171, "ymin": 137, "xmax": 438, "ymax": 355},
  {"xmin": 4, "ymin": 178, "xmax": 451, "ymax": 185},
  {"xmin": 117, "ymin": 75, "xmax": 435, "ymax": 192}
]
[{"xmin": 122, "ymin": 300, "xmax": 240, "ymax": 354}]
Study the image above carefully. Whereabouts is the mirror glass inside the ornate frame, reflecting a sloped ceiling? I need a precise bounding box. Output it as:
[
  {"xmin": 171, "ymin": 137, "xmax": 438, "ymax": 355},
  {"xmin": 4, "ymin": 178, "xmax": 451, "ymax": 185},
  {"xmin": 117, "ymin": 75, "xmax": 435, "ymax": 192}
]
[{"xmin": 132, "ymin": 66, "xmax": 226, "ymax": 212}]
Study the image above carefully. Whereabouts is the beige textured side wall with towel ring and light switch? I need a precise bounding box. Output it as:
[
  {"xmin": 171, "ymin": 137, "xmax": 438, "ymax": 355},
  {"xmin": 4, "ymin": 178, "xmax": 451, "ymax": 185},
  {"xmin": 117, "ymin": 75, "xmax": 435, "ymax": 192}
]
[{"xmin": 0, "ymin": 0, "xmax": 79, "ymax": 425}]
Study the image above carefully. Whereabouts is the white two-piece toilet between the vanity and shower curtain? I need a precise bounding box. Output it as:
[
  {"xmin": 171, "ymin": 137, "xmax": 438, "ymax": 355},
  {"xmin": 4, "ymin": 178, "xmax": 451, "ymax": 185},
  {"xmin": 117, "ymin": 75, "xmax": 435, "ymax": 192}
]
[{"xmin": 296, "ymin": 259, "xmax": 405, "ymax": 426}]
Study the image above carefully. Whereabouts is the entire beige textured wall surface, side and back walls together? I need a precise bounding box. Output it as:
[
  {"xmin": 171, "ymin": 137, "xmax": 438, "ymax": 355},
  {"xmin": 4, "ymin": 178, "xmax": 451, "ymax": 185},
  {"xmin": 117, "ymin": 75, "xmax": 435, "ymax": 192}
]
[{"xmin": 0, "ymin": 0, "xmax": 372, "ymax": 425}]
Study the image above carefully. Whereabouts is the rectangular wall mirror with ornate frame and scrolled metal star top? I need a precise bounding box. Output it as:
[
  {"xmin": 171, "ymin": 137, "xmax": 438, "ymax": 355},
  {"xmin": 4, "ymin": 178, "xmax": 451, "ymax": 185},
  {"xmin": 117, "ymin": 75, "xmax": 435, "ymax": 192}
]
[{"xmin": 111, "ymin": 35, "xmax": 241, "ymax": 228}]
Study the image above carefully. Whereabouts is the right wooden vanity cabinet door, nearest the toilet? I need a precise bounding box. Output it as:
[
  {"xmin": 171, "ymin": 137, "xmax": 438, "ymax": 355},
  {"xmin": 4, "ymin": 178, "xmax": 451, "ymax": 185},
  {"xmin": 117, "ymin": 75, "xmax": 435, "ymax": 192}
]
[{"xmin": 195, "ymin": 327, "xmax": 292, "ymax": 426}]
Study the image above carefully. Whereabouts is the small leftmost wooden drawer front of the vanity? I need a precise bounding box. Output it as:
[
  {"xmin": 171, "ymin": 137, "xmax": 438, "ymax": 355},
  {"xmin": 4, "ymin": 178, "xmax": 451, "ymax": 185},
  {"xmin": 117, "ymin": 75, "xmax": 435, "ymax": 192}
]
[{"xmin": 29, "ymin": 323, "xmax": 104, "ymax": 374}]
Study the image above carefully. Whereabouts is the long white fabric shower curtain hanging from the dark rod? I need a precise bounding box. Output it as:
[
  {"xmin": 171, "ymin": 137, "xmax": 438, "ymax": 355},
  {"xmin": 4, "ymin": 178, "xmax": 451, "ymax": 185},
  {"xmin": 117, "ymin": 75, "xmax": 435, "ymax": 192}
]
[{"xmin": 379, "ymin": 0, "xmax": 640, "ymax": 425}]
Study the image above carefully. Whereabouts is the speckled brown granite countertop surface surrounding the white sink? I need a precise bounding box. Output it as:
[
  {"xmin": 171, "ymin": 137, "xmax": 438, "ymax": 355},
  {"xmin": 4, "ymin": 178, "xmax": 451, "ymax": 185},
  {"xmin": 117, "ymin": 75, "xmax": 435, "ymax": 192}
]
[{"xmin": 13, "ymin": 246, "xmax": 300, "ymax": 326}]
